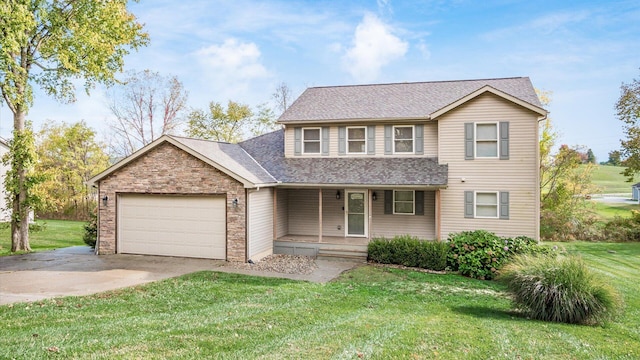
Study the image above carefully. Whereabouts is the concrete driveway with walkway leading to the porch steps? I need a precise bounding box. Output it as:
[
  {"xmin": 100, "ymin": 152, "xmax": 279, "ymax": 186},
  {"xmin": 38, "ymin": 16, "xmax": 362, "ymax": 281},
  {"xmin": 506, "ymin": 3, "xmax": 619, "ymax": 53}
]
[{"xmin": 0, "ymin": 246, "xmax": 362, "ymax": 305}]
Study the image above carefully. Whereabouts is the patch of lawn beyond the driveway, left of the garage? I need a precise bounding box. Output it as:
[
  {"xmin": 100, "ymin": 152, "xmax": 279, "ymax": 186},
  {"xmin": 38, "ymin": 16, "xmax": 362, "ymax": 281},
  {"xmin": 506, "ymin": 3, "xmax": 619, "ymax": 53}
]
[{"xmin": 0, "ymin": 220, "xmax": 85, "ymax": 256}]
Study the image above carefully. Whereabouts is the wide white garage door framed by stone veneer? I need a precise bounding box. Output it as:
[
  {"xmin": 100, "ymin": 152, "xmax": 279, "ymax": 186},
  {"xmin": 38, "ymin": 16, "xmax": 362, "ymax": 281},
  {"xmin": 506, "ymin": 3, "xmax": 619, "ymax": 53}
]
[{"xmin": 118, "ymin": 194, "xmax": 226, "ymax": 259}]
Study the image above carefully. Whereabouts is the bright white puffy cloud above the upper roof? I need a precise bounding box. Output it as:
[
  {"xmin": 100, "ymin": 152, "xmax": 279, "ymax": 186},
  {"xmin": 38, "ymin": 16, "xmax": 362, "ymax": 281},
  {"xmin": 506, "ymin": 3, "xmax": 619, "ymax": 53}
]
[{"xmin": 343, "ymin": 13, "xmax": 409, "ymax": 81}]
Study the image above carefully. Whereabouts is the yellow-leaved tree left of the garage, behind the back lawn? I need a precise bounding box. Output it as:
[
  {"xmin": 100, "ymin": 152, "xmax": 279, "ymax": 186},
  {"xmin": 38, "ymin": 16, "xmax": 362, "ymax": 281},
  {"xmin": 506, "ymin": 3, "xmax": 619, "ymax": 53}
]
[{"xmin": 35, "ymin": 121, "xmax": 109, "ymax": 220}]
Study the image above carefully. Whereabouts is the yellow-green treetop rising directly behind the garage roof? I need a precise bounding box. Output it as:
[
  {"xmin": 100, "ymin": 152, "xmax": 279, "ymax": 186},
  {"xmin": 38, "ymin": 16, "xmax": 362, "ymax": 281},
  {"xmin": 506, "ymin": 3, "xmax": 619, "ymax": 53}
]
[{"xmin": 187, "ymin": 100, "xmax": 253, "ymax": 143}]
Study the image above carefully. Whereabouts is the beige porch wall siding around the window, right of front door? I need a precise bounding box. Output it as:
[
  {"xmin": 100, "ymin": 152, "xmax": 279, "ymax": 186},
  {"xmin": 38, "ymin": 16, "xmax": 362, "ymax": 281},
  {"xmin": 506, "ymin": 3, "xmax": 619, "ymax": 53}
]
[{"xmin": 371, "ymin": 190, "xmax": 436, "ymax": 240}]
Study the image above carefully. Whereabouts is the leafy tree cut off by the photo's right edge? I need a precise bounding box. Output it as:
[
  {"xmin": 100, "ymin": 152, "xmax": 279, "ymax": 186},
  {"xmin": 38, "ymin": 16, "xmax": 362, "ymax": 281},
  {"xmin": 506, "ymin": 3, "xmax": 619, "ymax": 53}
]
[{"xmin": 615, "ymin": 71, "xmax": 640, "ymax": 181}]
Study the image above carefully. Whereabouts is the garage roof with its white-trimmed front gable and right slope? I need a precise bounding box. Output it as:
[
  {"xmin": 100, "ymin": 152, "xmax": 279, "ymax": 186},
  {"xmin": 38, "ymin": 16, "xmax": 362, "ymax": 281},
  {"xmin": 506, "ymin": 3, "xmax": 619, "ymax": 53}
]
[{"xmin": 88, "ymin": 135, "xmax": 276, "ymax": 187}]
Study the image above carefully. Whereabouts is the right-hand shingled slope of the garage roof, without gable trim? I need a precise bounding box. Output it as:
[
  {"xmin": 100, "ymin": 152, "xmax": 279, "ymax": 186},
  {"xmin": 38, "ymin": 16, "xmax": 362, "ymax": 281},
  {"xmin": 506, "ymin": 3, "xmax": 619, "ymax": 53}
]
[{"xmin": 171, "ymin": 136, "xmax": 276, "ymax": 184}]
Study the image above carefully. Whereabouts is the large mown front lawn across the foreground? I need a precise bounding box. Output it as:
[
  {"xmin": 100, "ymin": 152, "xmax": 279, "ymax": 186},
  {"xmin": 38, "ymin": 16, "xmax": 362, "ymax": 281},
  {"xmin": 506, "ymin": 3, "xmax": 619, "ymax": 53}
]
[{"xmin": 0, "ymin": 243, "xmax": 640, "ymax": 359}]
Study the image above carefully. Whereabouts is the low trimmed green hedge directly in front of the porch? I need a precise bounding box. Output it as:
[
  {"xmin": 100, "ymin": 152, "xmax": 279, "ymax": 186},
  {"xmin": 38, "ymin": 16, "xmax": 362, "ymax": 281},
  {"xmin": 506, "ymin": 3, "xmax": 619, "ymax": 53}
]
[{"xmin": 368, "ymin": 235, "xmax": 448, "ymax": 270}]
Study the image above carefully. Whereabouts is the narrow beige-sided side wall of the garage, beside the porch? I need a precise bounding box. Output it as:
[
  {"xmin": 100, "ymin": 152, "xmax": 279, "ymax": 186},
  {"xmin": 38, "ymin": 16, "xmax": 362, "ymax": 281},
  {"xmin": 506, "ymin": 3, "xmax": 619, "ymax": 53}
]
[{"xmin": 247, "ymin": 189, "xmax": 273, "ymax": 260}]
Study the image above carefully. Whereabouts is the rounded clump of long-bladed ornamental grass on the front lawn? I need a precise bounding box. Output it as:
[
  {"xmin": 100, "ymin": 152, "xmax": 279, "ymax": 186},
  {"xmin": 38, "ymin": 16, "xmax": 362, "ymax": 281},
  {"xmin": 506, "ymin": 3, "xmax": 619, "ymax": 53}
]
[{"xmin": 498, "ymin": 254, "xmax": 622, "ymax": 324}]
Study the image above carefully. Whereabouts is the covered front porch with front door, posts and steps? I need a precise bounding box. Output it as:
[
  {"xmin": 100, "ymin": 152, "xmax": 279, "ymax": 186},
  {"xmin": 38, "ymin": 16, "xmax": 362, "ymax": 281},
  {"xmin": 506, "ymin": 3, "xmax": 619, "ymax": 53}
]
[{"xmin": 273, "ymin": 187, "xmax": 439, "ymax": 259}]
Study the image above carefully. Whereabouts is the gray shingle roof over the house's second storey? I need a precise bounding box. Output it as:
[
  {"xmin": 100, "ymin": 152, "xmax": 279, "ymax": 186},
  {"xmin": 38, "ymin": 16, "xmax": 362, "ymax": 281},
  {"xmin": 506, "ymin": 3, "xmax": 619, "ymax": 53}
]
[{"xmin": 279, "ymin": 77, "xmax": 542, "ymax": 123}]
